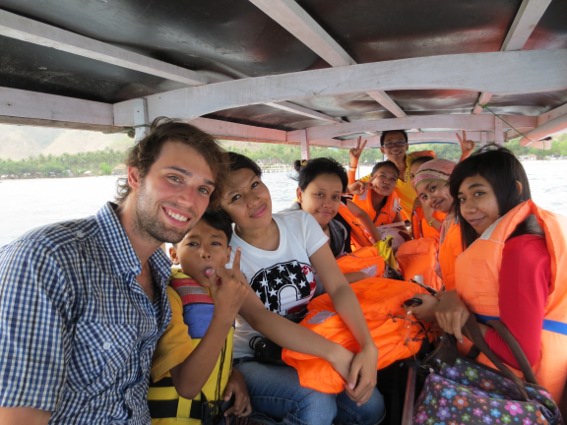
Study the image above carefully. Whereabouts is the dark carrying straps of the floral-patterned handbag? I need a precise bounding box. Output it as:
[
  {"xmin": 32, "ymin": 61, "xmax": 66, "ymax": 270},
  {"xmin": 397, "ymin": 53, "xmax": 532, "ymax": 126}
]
[{"xmin": 463, "ymin": 314, "xmax": 537, "ymax": 400}]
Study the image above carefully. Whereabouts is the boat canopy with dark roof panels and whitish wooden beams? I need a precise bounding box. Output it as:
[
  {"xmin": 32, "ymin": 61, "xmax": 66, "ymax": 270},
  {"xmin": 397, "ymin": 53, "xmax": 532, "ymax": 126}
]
[{"xmin": 0, "ymin": 0, "xmax": 567, "ymax": 153}]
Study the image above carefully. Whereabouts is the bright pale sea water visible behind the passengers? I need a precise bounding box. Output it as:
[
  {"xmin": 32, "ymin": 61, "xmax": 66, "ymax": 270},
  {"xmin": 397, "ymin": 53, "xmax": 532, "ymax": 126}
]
[{"xmin": 0, "ymin": 160, "xmax": 567, "ymax": 245}]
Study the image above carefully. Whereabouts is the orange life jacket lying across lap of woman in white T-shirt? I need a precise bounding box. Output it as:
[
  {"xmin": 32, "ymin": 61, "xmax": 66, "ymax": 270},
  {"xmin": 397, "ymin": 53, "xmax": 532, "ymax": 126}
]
[{"xmin": 282, "ymin": 277, "xmax": 432, "ymax": 393}]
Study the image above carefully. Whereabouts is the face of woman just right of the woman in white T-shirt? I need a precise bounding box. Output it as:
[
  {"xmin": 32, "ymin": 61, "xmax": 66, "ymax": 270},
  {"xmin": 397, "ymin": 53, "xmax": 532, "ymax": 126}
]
[{"xmin": 297, "ymin": 174, "xmax": 343, "ymax": 228}]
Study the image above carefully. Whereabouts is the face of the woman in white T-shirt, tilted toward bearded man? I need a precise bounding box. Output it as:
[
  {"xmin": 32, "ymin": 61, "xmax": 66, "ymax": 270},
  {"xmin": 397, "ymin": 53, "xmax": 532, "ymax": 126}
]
[{"xmin": 221, "ymin": 168, "xmax": 272, "ymax": 235}]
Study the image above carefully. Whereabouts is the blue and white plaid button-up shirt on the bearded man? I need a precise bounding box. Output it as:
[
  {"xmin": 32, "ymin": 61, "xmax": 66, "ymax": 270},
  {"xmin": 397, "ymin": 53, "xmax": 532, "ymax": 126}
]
[{"xmin": 0, "ymin": 203, "xmax": 171, "ymax": 424}]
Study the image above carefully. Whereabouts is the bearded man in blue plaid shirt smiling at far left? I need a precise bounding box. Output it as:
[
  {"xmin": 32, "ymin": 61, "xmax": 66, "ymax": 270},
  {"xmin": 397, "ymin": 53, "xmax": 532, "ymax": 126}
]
[{"xmin": 0, "ymin": 119, "xmax": 226, "ymax": 424}]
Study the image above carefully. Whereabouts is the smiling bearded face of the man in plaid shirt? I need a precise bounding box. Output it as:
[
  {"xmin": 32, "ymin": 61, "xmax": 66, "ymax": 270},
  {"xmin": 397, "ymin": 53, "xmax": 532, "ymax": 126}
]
[{"xmin": 128, "ymin": 141, "xmax": 215, "ymax": 244}]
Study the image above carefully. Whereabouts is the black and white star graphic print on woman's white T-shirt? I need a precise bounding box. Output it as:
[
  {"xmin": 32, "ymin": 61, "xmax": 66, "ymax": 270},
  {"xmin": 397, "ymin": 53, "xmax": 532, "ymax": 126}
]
[{"xmin": 250, "ymin": 261, "xmax": 316, "ymax": 314}]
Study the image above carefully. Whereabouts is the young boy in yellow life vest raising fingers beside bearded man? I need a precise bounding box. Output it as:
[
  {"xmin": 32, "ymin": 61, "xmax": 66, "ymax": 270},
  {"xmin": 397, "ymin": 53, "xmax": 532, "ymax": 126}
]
[{"xmin": 148, "ymin": 212, "xmax": 252, "ymax": 424}]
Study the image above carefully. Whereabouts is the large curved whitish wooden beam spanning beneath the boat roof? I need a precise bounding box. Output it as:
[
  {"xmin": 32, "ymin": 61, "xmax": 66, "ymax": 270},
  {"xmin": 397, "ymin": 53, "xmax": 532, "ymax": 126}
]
[{"xmin": 147, "ymin": 49, "xmax": 567, "ymax": 119}]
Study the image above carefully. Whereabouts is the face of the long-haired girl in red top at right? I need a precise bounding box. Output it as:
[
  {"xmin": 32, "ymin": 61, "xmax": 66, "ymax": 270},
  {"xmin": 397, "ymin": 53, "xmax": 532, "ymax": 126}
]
[{"xmin": 457, "ymin": 175, "xmax": 500, "ymax": 235}]
